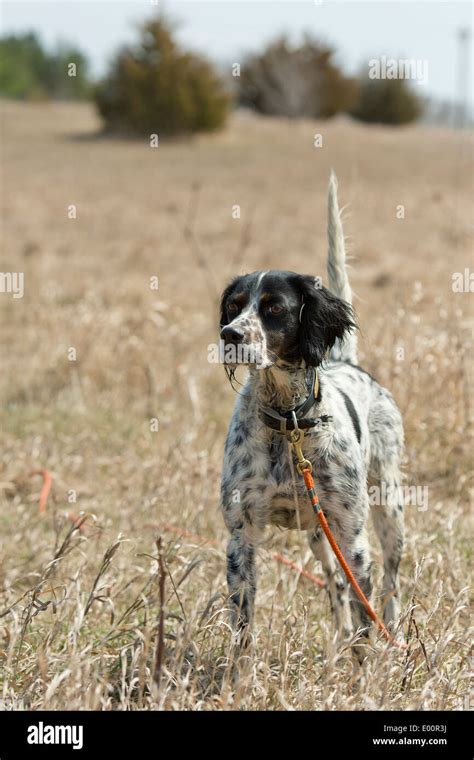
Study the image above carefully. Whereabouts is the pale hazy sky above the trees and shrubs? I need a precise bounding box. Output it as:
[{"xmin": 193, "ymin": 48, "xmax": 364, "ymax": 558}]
[{"xmin": 1, "ymin": 0, "xmax": 474, "ymax": 100}]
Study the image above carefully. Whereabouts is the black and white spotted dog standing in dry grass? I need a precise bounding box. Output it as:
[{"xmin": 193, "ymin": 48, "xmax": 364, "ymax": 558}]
[{"xmin": 221, "ymin": 175, "xmax": 403, "ymax": 656}]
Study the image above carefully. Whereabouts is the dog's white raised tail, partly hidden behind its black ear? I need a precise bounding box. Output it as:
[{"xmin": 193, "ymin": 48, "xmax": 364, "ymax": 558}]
[{"xmin": 327, "ymin": 171, "xmax": 357, "ymax": 364}]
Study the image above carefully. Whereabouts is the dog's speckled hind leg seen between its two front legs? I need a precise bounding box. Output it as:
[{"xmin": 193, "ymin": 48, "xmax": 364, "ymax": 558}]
[{"xmin": 308, "ymin": 528, "xmax": 352, "ymax": 638}]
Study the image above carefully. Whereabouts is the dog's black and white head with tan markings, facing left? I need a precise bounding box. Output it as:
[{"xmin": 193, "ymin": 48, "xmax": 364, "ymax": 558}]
[{"xmin": 220, "ymin": 270, "xmax": 356, "ymax": 368}]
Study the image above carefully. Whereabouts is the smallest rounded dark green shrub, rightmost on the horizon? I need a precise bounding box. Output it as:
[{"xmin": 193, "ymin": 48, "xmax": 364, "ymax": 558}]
[{"xmin": 351, "ymin": 77, "xmax": 423, "ymax": 124}]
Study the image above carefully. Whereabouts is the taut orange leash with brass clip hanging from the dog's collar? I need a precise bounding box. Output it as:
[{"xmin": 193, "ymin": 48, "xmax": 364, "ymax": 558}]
[{"xmin": 288, "ymin": 428, "xmax": 407, "ymax": 649}]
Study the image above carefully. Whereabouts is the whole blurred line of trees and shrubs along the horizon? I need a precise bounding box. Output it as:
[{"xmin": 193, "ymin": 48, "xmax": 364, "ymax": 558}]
[{"xmin": 0, "ymin": 17, "xmax": 422, "ymax": 135}]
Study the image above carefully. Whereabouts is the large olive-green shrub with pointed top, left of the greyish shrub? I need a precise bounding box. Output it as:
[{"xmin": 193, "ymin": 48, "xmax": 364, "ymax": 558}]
[{"xmin": 95, "ymin": 20, "xmax": 230, "ymax": 135}]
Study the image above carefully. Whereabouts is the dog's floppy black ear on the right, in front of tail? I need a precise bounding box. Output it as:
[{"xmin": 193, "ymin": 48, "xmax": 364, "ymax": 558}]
[{"xmin": 297, "ymin": 276, "xmax": 357, "ymax": 367}]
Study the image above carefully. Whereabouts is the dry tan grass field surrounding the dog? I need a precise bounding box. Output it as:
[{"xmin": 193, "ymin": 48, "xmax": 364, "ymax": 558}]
[{"xmin": 0, "ymin": 98, "xmax": 473, "ymax": 710}]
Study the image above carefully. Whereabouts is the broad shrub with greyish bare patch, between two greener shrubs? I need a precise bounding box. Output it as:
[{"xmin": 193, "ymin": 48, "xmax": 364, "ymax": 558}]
[{"xmin": 237, "ymin": 36, "xmax": 357, "ymax": 118}]
